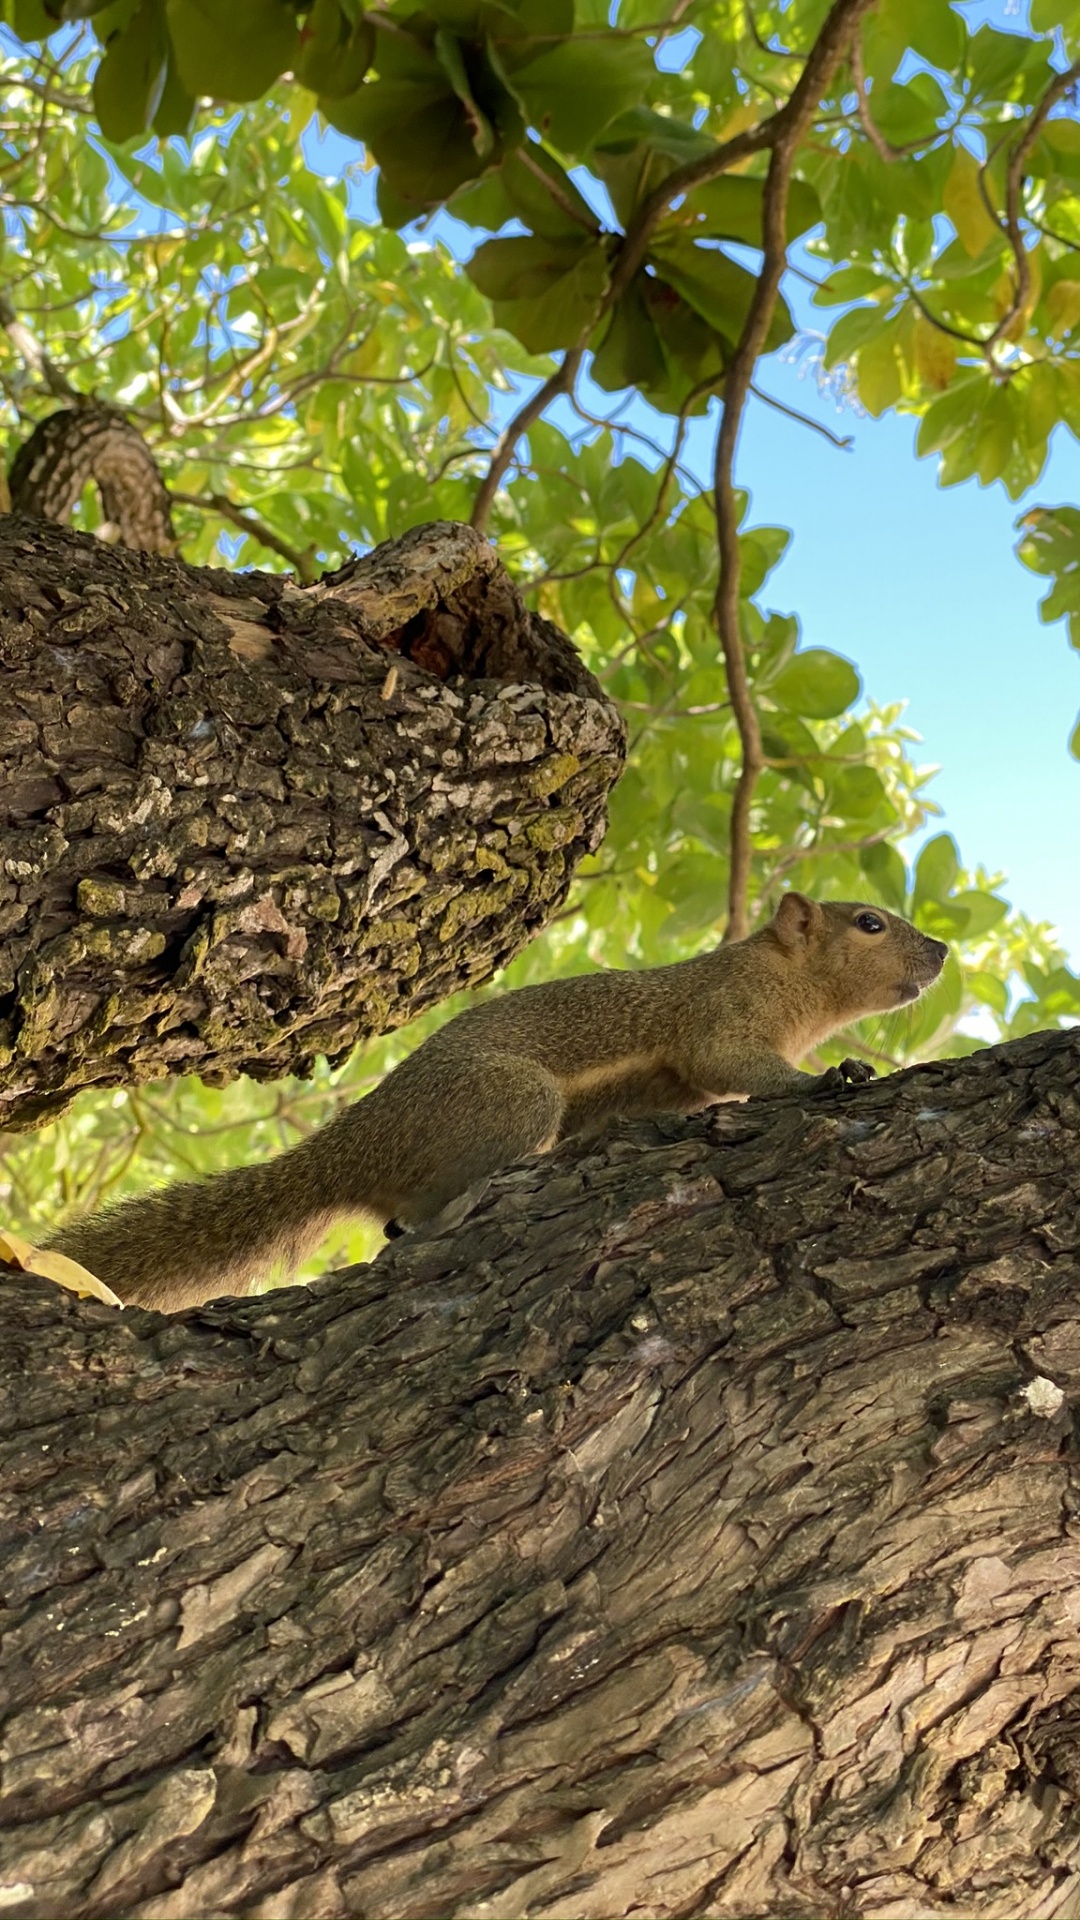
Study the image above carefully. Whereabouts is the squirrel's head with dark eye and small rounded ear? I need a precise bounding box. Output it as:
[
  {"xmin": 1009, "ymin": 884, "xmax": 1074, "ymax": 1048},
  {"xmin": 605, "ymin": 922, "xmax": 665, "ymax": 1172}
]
[{"xmin": 769, "ymin": 893, "xmax": 949, "ymax": 1020}]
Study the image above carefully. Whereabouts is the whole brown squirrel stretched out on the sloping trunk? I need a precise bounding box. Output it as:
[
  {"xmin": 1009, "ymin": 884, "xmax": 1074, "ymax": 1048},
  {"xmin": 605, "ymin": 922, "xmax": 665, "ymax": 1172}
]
[{"xmin": 46, "ymin": 893, "xmax": 947, "ymax": 1311}]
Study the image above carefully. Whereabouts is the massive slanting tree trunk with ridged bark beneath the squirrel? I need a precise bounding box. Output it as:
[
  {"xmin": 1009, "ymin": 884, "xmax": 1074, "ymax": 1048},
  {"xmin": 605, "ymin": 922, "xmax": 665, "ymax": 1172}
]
[{"xmin": 0, "ymin": 1035, "xmax": 1080, "ymax": 1920}]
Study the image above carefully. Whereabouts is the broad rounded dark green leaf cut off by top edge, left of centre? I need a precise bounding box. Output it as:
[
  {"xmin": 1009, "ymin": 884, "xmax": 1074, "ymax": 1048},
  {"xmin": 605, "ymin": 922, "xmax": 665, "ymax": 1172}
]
[{"xmin": 165, "ymin": 0, "xmax": 298, "ymax": 100}]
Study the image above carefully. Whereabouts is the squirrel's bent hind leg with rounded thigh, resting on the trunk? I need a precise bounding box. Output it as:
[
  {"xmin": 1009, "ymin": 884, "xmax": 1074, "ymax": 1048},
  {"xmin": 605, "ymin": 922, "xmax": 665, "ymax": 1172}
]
[{"xmin": 384, "ymin": 1060, "xmax": 565, "ymax": 1238}]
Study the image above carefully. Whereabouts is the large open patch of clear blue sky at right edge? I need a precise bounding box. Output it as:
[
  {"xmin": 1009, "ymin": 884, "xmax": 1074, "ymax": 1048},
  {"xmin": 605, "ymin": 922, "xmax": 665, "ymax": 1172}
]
[{"xmin": 714, "ymin": 355, "xmax": 1080, "ymax": 962}]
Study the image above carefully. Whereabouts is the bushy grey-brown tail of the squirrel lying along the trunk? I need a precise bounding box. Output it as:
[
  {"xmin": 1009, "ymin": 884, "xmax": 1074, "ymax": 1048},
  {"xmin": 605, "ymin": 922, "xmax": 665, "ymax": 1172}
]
[{"xmin": 46, "ymin": 1135, "xmax": 365, "ymax": 1313}]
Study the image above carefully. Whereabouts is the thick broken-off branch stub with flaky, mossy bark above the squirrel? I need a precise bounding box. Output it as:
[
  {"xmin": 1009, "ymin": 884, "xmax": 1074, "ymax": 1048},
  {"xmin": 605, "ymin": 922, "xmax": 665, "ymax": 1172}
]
[{"xmin": 0, "ymin": 518, "xmax": 623, "ymax": 1127}]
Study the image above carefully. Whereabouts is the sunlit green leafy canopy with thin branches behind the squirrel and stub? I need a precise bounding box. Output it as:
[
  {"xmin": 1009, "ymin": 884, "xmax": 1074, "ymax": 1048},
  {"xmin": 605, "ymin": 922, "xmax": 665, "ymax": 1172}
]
[{"xmin": 0, "ymin": 0, "xmax": 1080, "ymax": 1274}]
